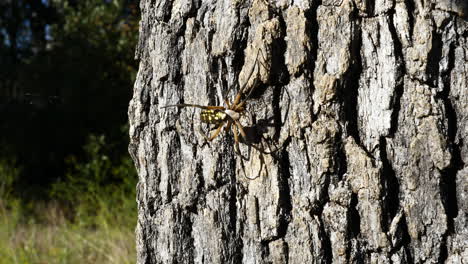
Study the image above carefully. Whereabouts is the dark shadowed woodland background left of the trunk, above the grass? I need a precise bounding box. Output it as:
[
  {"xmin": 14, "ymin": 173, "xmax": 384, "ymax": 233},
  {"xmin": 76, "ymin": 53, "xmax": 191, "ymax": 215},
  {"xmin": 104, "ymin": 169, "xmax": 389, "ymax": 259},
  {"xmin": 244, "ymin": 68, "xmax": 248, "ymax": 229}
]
[{"xmin": 0, "ymin": 0, "xmax": 139, "ymax": 198}]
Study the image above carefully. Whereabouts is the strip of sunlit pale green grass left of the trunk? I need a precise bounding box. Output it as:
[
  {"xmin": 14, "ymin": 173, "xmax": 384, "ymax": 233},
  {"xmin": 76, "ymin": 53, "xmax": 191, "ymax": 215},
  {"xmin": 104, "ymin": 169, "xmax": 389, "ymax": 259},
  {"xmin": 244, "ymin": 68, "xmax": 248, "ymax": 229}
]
[{"xmin": 0, "ymin": 201, "xmax": 136, "ymax": 264}]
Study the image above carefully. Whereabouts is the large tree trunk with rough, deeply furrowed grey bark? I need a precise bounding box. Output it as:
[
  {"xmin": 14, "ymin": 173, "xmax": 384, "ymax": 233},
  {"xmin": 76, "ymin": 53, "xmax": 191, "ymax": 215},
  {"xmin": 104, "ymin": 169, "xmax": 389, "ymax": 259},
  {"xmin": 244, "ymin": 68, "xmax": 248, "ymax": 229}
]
[{"xmin": 129, "ymin": 0, "xmax": 468, "ymax": 264}]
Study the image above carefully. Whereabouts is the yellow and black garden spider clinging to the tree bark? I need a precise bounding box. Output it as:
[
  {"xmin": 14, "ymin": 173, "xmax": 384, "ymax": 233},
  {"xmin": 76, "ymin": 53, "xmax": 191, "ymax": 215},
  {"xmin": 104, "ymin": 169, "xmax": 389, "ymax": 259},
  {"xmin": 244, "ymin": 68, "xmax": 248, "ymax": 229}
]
[{"xmin": 161, "ymin": 50, "xmax": 266, "ymax": 165}]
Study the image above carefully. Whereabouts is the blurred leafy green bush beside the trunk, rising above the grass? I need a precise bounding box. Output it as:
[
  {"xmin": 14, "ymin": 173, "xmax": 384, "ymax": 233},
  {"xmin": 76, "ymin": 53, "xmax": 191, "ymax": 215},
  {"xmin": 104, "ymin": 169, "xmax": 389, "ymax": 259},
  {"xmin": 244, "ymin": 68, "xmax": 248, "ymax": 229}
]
[{"xmin": 51, "ymin": 129, "xmax": 137, "ymax": 227}]
